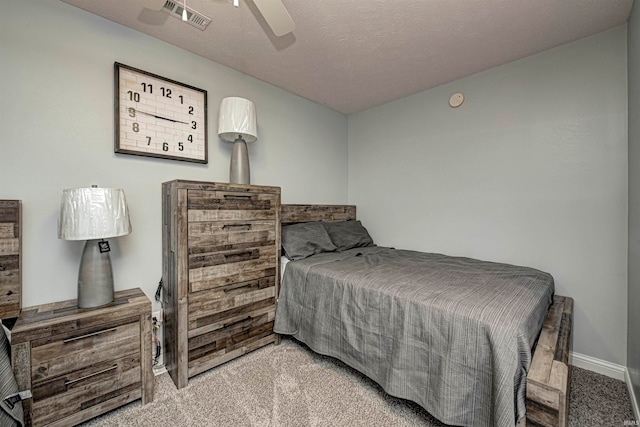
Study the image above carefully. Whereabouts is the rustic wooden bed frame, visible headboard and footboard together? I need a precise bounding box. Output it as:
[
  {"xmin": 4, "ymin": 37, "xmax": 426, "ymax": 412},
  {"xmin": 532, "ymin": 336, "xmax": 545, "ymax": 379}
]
[{"xmin": 281, "ymin": 204, "xmax": 573, "ymax": 427}]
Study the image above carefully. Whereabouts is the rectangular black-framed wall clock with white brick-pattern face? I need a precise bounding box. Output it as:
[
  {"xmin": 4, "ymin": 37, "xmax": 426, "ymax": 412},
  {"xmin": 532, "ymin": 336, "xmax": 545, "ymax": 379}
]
[{"xmin": 114, "ymin": 62, "xmax": 208, "ymax": 163}]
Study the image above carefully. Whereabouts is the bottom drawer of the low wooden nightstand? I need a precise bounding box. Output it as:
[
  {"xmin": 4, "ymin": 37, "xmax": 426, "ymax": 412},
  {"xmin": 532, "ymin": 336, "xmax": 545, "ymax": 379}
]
[{"xmin": 32, "ymin": 352, "xmax": 141, "ymax": 425}]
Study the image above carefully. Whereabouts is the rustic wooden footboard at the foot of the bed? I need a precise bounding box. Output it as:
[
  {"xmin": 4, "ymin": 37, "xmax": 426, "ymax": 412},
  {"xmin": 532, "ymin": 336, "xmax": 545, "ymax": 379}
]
[{"xmin": 526, "ymin": 295, "xmax": 573, "ymax": 427}]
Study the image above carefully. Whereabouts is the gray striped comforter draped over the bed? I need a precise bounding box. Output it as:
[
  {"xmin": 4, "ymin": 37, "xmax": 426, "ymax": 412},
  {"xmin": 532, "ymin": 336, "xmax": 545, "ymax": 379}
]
[{"xmin": 274, "ymin": 247, "xmax": 554, "ymax": 427}]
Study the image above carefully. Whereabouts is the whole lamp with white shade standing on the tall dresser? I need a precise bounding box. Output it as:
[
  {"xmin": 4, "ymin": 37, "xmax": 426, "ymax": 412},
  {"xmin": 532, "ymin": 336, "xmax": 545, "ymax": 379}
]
[{"xmin": 218, "ymin": 97, "xmax": 258, "ymax": 184}]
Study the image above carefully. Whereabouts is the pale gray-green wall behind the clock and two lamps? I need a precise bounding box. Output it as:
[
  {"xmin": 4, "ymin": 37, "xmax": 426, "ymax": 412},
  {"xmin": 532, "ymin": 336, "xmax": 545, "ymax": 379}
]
[{"xmin": 0, "ymin": 0, "xmax": 347, "ymax": 308}]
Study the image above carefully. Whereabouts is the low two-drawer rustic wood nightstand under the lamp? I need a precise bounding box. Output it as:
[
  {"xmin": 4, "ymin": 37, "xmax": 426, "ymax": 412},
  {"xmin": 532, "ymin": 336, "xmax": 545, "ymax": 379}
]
[{"xmin": 11, "ymin": 289, "xmax": 154, "ymax": 426}]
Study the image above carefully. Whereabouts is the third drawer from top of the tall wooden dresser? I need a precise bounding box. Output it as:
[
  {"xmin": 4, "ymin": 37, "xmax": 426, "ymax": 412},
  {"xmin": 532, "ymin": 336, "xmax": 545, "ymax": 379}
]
[{"xmin": 189, "ymin": 245, "xmax": 277, "ymax": 292}]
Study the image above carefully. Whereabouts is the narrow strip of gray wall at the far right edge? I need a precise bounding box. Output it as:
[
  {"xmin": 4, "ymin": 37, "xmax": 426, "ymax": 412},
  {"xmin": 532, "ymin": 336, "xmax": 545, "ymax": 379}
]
[{"xmin": 627, "ymin": 3, "xmax": 640, "ymax": 415}]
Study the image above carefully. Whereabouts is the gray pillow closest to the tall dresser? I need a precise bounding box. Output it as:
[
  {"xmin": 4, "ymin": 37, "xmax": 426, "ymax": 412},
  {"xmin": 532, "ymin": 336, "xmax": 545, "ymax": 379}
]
[{"xmin": 282, "ymin": 222, "xmax": 337, "ymax": 261}]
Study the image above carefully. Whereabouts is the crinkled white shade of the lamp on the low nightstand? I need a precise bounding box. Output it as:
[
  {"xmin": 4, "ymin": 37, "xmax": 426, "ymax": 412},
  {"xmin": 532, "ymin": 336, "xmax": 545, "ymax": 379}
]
[{"xmin": 58, "ymin": 187, "xmax": 131, "ymax": 240}]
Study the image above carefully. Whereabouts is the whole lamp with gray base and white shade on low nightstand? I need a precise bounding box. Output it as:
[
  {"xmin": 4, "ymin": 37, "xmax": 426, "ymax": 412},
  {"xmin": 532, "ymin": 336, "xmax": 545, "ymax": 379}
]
[{"xmin": 58, "ymin": 186, "xmax": 131, "ymax": 308}]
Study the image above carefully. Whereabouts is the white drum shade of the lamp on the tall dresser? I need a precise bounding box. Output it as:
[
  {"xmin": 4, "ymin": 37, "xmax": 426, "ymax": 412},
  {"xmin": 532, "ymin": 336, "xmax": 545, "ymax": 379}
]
[{"xmin": 218, "ymin": 97, "xmax": 258, "ymax": 142}]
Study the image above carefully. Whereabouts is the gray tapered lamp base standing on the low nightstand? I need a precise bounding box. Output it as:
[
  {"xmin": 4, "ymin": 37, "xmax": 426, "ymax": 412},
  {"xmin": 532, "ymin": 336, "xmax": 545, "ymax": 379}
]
[{"xmin": 78, "ymin": 239, "xmax": 113, "ymax": 308}]
